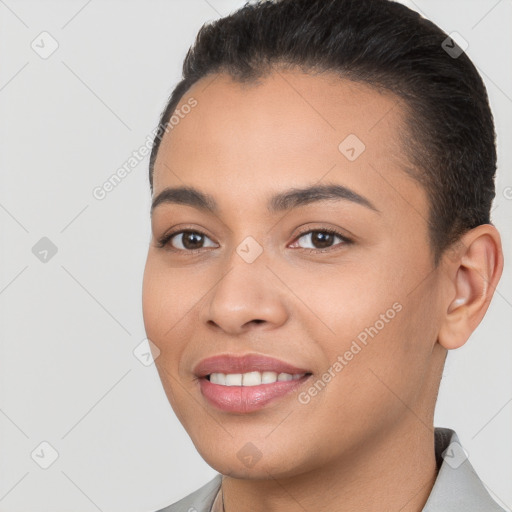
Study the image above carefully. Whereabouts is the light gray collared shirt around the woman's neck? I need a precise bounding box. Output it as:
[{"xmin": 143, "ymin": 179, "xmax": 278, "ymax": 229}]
[{"xmin": 158, "ymin": 428, "xmax": 505, "ymax": 512}]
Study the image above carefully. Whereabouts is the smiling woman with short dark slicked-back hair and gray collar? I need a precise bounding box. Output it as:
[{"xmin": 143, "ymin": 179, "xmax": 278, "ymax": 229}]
[{"xmin": 143, "ymin": 0, "xmax": 503, "ymax": 512}]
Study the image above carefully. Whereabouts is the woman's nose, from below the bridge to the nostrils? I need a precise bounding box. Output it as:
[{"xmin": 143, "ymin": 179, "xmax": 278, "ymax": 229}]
[{"xmin": 201, "ymin": 253, "xmax": 288, "ymax": 335}]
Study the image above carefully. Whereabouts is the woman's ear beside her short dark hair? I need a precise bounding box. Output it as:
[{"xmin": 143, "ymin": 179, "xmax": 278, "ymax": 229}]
[{"xmin": 438, "ymin": 224, "xmax": 503, "ymax": 349}]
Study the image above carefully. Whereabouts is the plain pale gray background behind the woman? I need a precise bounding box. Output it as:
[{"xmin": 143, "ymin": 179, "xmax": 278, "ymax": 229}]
[{"xmin": 0, "ymin": 0, "xmax": 512, "ymax": 512}]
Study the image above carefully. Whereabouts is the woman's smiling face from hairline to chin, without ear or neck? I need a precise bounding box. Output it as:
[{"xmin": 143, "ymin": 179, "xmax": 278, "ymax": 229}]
[{"xmin": 143, "ymin": 71, "xmax": 444, "ymax": 478}]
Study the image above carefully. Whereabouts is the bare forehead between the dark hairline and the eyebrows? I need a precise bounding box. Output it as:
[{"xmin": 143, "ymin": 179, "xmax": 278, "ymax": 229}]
[{"xmin": 153, "ymin": 67, "xmax": 424, "ymax": 218}]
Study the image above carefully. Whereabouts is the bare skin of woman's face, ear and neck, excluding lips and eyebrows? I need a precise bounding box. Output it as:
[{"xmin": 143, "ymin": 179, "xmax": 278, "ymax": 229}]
[{"xmin": 143, "ymin": 69, "xmax": 503, "ymax": 512}]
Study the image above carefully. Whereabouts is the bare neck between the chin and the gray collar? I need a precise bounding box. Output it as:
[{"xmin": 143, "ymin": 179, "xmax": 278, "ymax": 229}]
[{"xmin": 222, "ymin": 415, "xmax": 437, "ymax": 512}]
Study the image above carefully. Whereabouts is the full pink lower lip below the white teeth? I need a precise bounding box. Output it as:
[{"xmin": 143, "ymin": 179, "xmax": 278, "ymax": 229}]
[{"xmin": 199, "ymin": 374, "xmax": 311, "ymax": 413}]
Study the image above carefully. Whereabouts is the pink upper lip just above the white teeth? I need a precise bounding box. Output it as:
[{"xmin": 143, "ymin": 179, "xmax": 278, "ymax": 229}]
[{"xmin": 194, "ymin": 354, "xmax": 310, "ymax": 377}]
